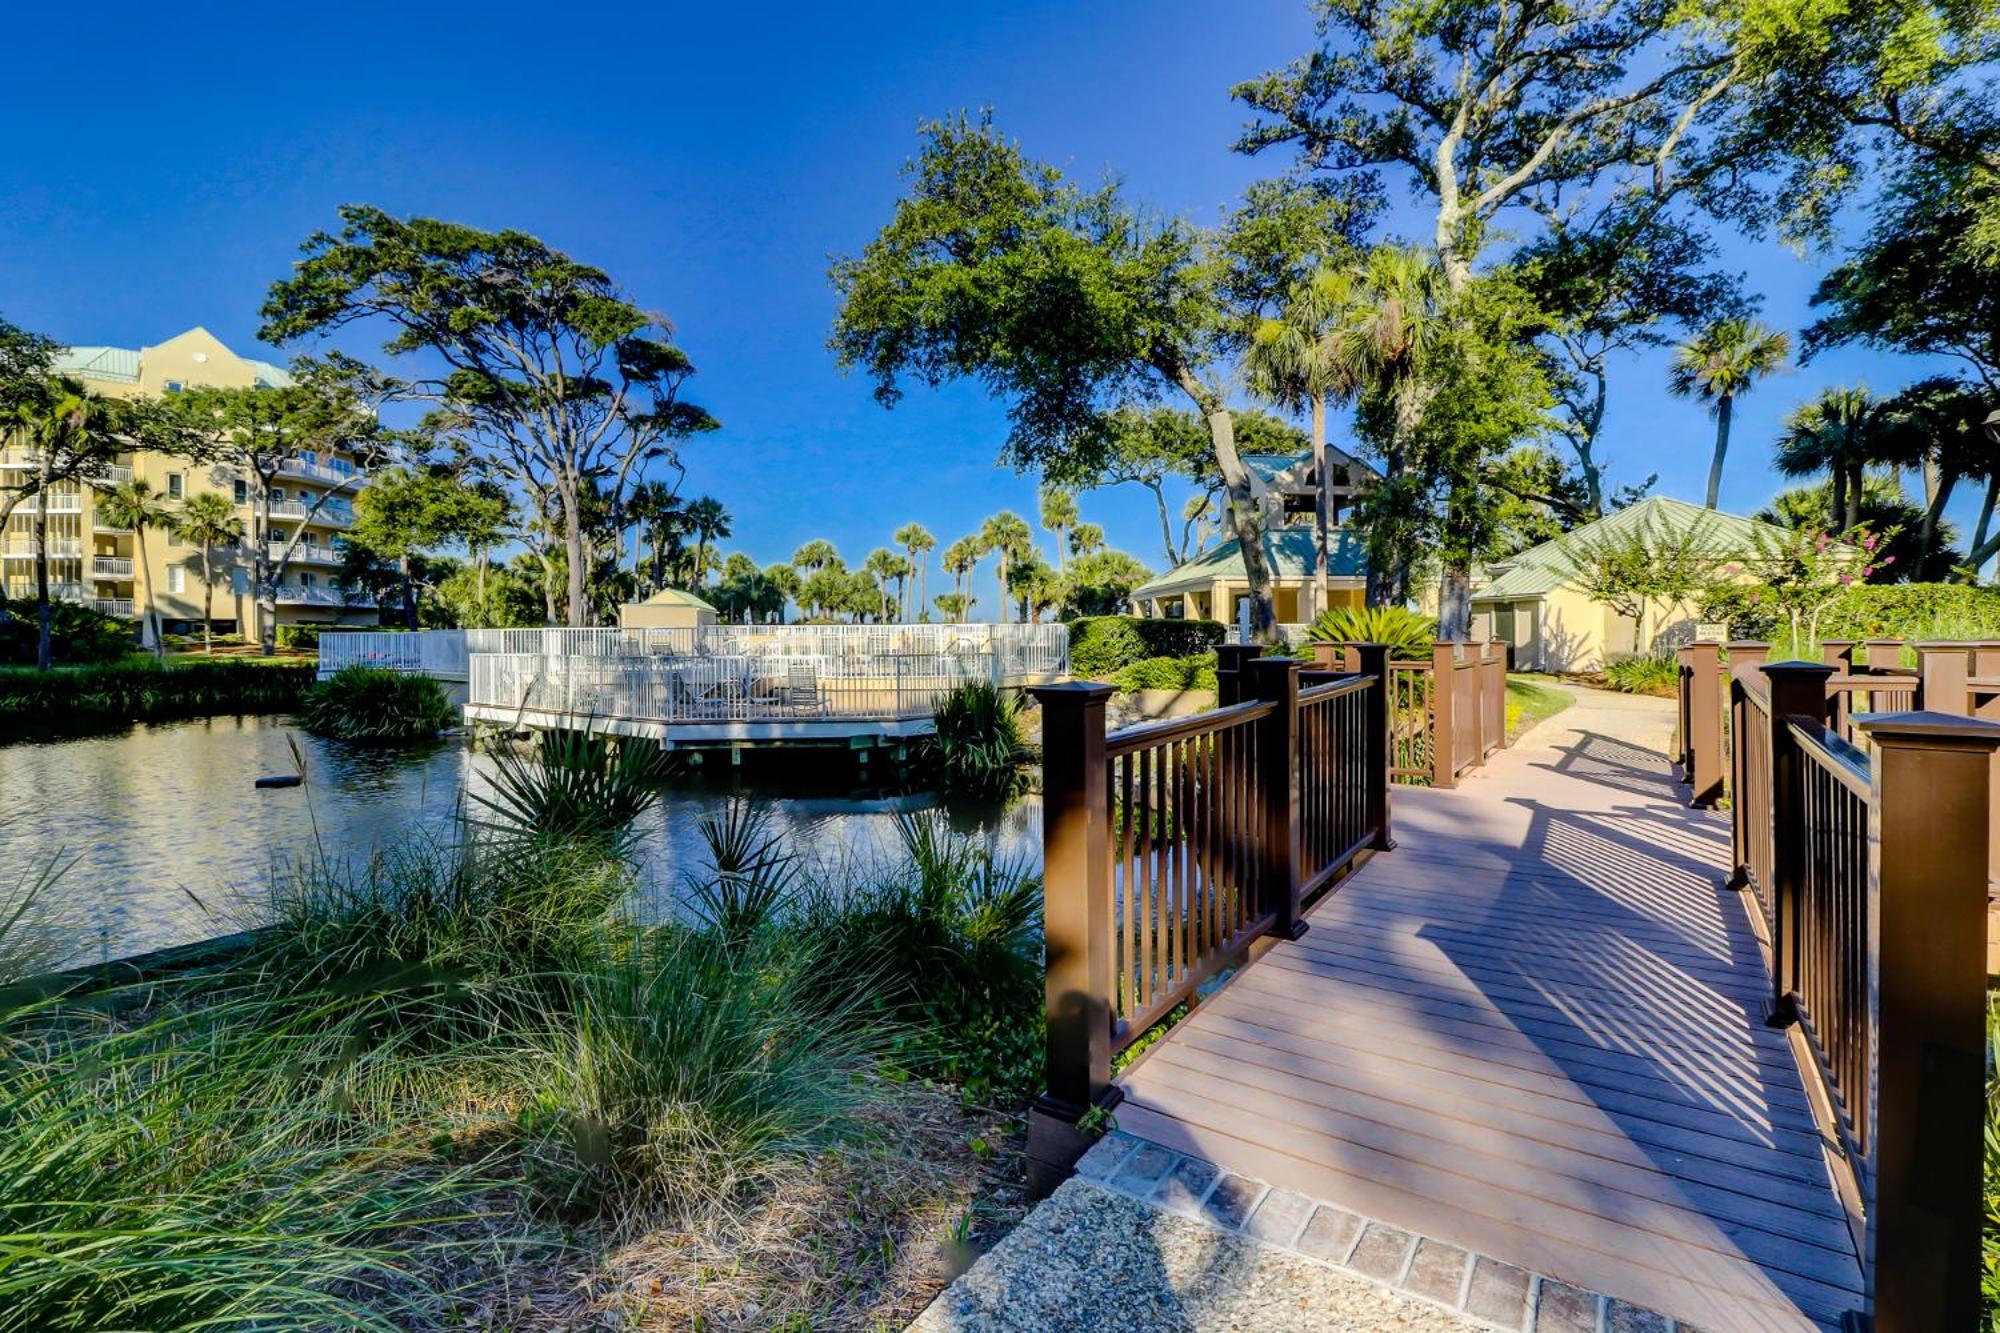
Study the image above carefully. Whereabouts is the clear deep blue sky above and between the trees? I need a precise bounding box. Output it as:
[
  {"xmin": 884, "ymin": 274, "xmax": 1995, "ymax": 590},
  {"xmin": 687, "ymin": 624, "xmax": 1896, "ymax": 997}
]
[{"xmin": 0, "ymin": 0, "xmax": 1976, "ymax": 618}]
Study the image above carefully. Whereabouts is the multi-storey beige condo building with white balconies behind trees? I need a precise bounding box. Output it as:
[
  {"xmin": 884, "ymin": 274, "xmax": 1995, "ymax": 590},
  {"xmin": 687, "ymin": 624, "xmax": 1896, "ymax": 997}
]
[{"xmin": 0, "ymin": 328, "xmax": 376, "ymax": 636}]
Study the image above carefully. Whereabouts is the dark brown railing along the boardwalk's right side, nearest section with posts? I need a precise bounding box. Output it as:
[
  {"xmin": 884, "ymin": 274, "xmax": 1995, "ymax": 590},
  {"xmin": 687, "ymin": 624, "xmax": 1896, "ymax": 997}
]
[{"xmin": 1720, "ymin": 660, "xmax": 2000, "ymax": 1331}]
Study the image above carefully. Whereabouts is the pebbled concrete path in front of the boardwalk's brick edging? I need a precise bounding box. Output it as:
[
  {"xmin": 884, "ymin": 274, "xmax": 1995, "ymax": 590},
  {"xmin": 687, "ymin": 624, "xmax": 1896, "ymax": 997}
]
[{"xmin": 910, "ymin": 1179, "xmax": 1486, "ymax": 1333}]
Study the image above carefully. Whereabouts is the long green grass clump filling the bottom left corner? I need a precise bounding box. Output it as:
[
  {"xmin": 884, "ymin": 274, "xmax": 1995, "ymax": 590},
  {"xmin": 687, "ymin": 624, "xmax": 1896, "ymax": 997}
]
[{"xmin": 0, "ymin": 997, "xmax": 478, "ymax": 1333}]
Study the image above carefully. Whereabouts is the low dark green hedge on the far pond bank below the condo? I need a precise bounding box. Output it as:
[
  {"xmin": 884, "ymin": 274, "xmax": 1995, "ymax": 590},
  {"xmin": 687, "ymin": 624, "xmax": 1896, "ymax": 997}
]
[{"xmin": 0, "ymin": 658, "xmax": 314, "ymax": 723}]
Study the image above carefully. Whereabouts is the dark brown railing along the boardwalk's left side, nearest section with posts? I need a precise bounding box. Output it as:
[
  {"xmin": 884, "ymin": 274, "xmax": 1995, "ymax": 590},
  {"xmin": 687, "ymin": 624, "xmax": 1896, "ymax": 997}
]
[{"xmin": 1028, "ymin": 644, "xmax": 1392, "ymax": 1189}]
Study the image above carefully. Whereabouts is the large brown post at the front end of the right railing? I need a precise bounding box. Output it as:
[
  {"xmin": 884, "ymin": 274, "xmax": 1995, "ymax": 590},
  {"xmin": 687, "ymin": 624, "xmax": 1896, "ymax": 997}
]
[{"xmin": 1858, "ymin": 713, "xmax": 2000, "ymax": 1333}]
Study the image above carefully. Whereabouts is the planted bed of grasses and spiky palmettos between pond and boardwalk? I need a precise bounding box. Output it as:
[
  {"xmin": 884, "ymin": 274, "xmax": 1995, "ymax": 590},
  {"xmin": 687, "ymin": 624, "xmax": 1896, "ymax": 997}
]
[{"xmin": 0, "ymin": 733, "xmax": 1040, "ymax": 1333}]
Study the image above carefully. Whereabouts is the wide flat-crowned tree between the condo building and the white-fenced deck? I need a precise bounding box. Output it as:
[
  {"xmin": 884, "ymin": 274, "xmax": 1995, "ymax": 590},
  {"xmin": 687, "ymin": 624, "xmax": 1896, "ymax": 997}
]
[{"xmin": 262, "ymin": 206, "xmax": 716, "ymax": 626}]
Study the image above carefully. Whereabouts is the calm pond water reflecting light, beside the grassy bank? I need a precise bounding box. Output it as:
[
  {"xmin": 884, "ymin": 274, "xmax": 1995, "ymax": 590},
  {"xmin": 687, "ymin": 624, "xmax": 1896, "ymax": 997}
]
[{"xmin": 0, "ymin": 717, "xmax": 1040, "ymax": 959}]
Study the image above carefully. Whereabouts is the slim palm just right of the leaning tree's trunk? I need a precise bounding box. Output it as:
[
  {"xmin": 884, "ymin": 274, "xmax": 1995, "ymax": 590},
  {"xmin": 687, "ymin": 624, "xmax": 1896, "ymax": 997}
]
[{"xmin": 1244, "ymin": 264, "xmax": 1366, "ymax": 620}]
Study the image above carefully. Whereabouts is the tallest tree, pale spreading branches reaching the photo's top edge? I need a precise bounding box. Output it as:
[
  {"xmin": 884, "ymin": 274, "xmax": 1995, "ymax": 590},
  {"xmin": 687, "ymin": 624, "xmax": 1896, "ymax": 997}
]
[{"xmin": 1234, "ymin": 0, "xmax": 1742, "ymax": 636}]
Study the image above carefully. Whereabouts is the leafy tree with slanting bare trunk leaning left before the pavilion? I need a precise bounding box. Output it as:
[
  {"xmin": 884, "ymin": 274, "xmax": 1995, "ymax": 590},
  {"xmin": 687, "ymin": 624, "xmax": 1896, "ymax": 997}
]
[{"xmin": 830, "ymin": 116, "xmax": 1336, "ymax": 640}]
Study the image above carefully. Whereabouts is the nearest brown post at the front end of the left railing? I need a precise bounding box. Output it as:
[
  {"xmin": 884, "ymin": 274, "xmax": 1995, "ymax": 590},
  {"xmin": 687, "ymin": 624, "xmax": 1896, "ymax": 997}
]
[{"xmin": 1028, "ymin": 681, "xmax": 1118, "ymax": 1195}]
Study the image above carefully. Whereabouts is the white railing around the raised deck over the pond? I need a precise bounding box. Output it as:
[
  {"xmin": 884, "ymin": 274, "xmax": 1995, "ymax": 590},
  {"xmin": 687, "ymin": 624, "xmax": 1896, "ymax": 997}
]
[{"xmin": 468, "ymin": 652, "xmax": 1002, "ymax": 723}]
